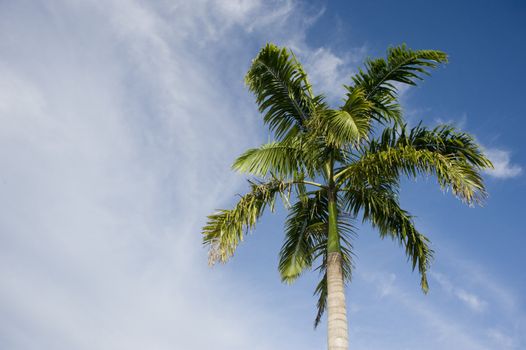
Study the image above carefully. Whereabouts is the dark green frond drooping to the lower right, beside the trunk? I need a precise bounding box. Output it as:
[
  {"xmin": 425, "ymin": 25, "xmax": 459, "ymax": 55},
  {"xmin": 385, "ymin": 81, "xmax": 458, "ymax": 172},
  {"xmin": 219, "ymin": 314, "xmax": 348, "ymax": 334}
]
[{"xmin": 343, "ymin": 183, "xmax": 433, "ymax": 293}]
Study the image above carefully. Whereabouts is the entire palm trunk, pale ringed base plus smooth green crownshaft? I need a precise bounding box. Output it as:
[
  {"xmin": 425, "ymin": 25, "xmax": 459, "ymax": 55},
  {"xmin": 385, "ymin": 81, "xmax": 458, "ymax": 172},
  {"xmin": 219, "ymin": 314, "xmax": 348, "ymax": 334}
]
[{"xmin": 327, "ymin": 190, "xmax": 349, "ymax": 350}]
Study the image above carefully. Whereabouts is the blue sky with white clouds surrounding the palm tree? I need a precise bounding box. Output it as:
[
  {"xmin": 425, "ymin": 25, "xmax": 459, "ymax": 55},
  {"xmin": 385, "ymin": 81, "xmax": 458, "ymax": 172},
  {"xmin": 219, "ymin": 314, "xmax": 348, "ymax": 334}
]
[{"xmin": 0, "ymin": 0, "xmax": 526, "ymax": 350}]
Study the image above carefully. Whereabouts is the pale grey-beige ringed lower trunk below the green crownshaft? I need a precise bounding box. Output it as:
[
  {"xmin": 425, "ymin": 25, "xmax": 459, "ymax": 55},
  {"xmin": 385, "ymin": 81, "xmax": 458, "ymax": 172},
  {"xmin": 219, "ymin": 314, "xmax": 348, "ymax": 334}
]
[{"xmin": 327, "ymin": 252, "xmax": 349, "ymax": 350}]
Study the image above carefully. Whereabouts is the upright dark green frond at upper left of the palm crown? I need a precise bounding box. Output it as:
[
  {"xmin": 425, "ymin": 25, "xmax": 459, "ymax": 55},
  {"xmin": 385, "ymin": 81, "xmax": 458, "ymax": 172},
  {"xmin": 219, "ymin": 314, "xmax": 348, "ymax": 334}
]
[{"xmin": 245, "ymin": 44, "xmax": 321, "ymax": 139}]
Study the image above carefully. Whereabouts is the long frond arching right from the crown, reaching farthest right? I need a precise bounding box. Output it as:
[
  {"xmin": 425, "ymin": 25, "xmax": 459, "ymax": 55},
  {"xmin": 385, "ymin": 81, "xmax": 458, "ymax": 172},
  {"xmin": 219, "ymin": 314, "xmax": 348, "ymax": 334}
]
[{"xmin": 336, "ymin": 126, "xmax": 491, "ymax": 204}]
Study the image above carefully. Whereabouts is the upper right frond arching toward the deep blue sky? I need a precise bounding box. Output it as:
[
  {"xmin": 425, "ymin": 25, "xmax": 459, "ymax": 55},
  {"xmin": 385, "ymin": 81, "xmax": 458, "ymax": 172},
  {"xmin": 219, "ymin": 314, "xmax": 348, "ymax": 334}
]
[{"xmin": 347, "ymin": 45, "xmax": 447, "ymax": 123}]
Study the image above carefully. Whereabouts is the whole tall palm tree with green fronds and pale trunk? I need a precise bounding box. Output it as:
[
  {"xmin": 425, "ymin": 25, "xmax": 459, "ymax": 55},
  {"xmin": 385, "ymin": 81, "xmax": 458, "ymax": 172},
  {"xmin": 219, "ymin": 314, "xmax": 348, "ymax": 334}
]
[{"xmin": 203, "ymin": 44, "xmax": 492, "ymax": 350}]
